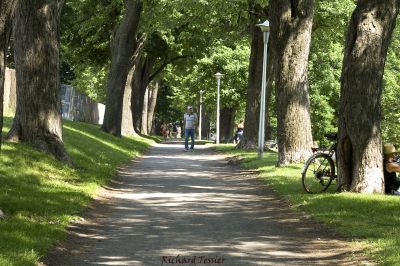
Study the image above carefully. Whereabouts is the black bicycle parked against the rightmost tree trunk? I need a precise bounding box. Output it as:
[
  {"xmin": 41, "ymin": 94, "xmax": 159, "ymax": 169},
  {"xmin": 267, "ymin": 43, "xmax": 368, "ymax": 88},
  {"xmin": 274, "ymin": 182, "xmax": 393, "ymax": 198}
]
[{"xmin": 301, "ymin": 133, "xmax": 337, "ymax": 193}]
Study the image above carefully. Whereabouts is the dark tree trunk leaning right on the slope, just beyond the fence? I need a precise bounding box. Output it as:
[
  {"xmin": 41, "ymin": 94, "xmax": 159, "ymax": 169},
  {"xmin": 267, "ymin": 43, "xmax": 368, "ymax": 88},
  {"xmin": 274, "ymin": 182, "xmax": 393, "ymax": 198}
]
[{"xmin": 101, "ymin": 0, "xmax": 142, "ymax": 136}]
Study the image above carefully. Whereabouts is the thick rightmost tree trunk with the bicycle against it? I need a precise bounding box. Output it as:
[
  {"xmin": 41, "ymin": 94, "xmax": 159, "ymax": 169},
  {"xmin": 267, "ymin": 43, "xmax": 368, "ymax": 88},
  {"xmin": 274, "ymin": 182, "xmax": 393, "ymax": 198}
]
[{"xmin": 338, "ymin": 0, "xmax": 399, "ymax": 193}]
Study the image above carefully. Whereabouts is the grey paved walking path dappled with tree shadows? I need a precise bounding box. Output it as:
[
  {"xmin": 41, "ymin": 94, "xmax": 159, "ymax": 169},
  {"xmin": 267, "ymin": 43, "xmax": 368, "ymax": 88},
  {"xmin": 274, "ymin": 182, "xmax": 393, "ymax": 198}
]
[{"xmin": 44, "ymin": 144, "xmax": 368, "ymax": 266}]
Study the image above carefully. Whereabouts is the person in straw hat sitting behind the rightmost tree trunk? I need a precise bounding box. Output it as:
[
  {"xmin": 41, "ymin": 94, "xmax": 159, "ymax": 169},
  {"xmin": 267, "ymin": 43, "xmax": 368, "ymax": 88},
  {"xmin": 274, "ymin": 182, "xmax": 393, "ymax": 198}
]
[{"xmin": 383, "ymin": 143, "xmax": 400, "ymax": 195}]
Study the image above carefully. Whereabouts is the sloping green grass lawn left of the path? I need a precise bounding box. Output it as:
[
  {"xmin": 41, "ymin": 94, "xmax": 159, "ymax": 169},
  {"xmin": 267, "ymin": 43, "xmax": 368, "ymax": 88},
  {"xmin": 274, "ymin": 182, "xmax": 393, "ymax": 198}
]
[{"xmin": 0, "ymin": 118, "xmax": 152, "ymax": 266}]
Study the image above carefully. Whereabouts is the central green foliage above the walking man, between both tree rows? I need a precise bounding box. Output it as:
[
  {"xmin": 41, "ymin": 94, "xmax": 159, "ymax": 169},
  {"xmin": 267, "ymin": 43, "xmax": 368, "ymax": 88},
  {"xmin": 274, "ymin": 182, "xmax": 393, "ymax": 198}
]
[{"xmin": 142, "ymin": 0, "xmax": 248, "ymax": 127}]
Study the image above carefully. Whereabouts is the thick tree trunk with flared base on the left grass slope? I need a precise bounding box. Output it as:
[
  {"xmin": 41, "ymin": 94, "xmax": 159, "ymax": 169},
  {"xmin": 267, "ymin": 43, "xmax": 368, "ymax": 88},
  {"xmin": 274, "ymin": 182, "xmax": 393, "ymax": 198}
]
[{"xmin": 8, "ymin": 0, "xmax": 71, "ymax": 163}]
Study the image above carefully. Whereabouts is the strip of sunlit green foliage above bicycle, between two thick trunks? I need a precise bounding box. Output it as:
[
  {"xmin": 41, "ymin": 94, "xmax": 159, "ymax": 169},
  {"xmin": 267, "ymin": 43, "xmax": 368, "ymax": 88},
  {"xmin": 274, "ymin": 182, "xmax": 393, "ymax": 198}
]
[{"xmin": 308, "ymin": 0, "xmax": 355, "ymax": 142}]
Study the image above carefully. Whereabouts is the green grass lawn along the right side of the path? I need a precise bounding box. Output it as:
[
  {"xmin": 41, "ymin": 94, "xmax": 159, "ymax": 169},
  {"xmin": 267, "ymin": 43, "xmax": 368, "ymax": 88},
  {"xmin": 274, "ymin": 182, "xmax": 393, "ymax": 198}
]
[{"xmin": 217, "ymin": 145, "xmax": 400, "ymax": 265}]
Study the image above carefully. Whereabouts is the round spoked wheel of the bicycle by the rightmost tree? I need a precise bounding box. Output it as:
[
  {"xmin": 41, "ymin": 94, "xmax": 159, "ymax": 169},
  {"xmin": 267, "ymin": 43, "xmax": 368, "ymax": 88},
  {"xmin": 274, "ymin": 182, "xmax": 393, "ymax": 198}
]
[{"xmin": 301, "ymin": 153, "xmax": 335, "ymax": 193}]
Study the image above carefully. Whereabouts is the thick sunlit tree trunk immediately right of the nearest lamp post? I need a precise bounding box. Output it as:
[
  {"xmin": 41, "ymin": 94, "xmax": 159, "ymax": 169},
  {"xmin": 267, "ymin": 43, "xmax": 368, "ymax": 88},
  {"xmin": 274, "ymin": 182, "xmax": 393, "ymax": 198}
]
[{"xmin": 270, "ymin": 0, "xmax": 314, "ymax": 165}]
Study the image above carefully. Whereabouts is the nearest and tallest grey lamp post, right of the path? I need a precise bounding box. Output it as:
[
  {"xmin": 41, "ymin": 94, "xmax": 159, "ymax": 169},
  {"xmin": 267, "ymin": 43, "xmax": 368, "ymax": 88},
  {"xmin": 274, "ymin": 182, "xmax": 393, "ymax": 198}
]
[{"xmin": 257, "ymin": 20, "xmax": 269, "ymax": 158}]
